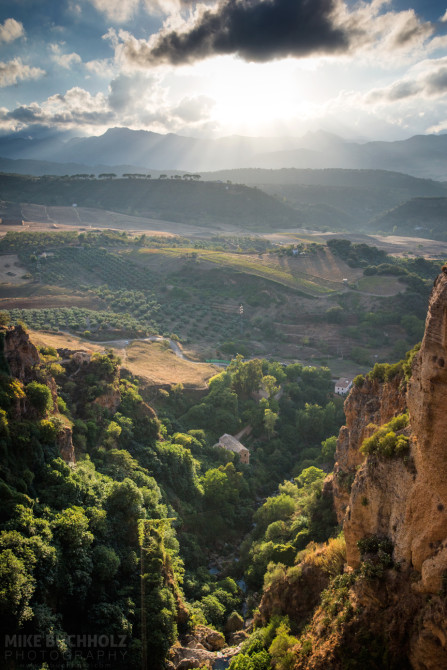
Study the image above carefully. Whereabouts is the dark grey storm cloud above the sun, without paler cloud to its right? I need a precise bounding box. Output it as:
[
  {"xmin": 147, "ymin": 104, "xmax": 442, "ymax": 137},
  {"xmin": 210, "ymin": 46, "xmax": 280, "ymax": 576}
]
[{"xmin": 125, "ymin": 0, "xmax": 350, "ymax": 65}]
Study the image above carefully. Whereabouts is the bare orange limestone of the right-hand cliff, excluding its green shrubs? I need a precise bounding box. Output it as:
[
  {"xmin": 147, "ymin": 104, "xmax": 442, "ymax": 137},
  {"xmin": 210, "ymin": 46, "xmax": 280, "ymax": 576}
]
[{"xmin": 318, "ymin": 273, "xmax": 447, "ymax": 670}]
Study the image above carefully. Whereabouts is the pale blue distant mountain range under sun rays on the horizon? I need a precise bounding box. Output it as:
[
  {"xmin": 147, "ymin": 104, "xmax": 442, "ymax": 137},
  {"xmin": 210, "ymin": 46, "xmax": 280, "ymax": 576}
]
[{"xmin": 0, "ymin": 128, "xmax": 447, "ymax": 181}]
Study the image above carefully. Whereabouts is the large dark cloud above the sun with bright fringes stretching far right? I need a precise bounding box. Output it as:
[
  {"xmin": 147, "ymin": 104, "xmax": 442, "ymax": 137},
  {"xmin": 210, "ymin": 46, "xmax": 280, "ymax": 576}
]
[{"xmin": 108, "ymin": 0, "xmax": 434, "ymax": 67}]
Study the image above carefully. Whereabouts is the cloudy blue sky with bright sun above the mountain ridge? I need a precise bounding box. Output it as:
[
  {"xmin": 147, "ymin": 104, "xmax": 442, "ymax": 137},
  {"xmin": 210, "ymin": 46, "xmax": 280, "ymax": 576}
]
[{"xmin": 0, "ymin": 0, "xmax": 447, "ymax": 141}]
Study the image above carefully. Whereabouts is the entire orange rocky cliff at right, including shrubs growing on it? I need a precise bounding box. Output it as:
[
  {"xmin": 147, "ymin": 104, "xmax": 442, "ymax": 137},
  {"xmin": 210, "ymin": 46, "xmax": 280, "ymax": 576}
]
[{"xmin": 296, "ymin": 268, "xmax": 447, "ymax": 670}]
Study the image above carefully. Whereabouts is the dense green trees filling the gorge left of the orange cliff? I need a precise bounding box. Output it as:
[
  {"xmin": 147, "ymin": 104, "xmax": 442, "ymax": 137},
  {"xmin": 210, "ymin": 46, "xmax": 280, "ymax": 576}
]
[{"xmin": 0, "ymin": 330, "xmax": 343, "ymax": 669}]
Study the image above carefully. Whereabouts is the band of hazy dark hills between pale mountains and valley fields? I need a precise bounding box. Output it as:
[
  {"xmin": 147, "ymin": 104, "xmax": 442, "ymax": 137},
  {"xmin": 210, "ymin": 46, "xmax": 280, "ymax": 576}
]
[{"xmin": 0, "ymin": 168, "xmax": 447, "ymax": 239}]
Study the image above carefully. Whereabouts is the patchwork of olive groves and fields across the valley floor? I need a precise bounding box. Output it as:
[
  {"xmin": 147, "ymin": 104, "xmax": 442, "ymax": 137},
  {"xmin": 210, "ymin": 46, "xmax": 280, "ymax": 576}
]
[{"xmin": 0, "ymin": 229, "xmax": 438, "ymax": 378}]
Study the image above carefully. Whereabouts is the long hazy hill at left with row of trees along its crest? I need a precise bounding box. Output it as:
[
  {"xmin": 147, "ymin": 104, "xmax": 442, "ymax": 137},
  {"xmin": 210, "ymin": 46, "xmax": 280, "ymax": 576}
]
[{"xmin": 0, "ymin": 175, "xmax": 301, "ymax": 230}]
